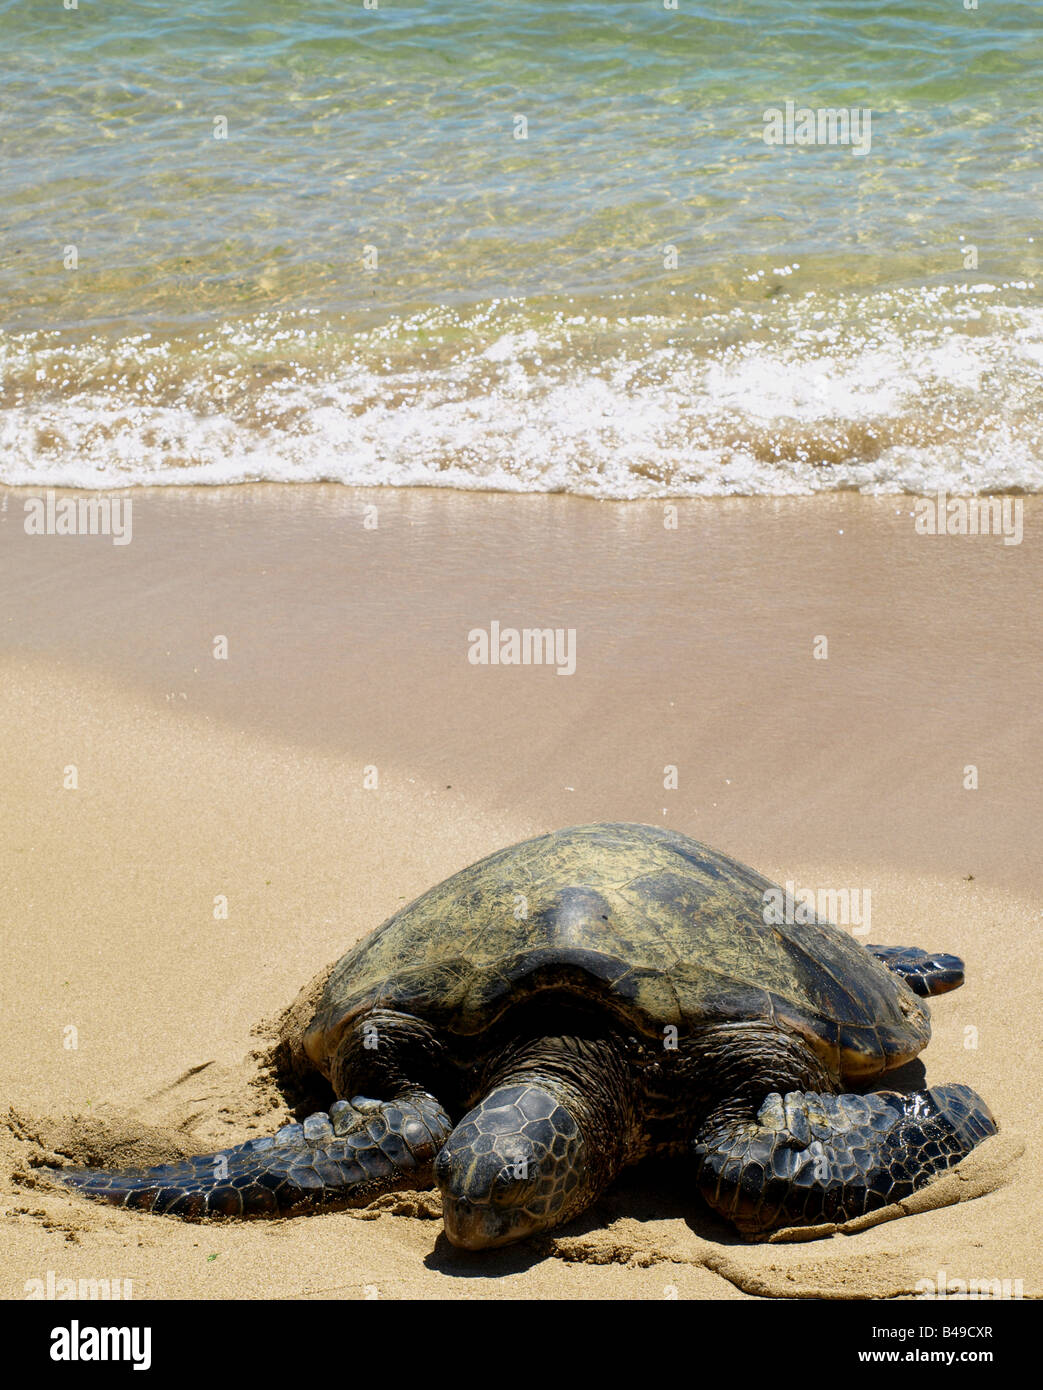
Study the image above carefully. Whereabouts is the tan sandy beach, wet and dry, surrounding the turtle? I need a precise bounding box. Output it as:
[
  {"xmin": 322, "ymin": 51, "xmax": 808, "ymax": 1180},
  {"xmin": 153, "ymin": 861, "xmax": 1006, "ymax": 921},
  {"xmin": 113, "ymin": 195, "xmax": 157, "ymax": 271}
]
[{"xmin": 0, "ymin": 485, "xmax": 1043, "ymax": 1298}]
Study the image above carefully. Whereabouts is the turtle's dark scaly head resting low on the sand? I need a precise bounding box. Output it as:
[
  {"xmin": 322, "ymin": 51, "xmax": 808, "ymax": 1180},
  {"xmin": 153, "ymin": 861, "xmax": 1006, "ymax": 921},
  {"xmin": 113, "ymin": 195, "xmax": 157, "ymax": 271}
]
[{"xmin": 435, "ymin": 1077, "xmax": 594, "ymax": 1250}]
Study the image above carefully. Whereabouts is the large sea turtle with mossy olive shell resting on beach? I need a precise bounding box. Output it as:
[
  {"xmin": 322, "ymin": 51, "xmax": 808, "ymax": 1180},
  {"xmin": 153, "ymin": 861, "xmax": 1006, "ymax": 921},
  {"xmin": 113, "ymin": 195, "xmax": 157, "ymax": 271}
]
[{"xmin": 53, "ymin": 824, "xmax": 996, "ymax": 1250}]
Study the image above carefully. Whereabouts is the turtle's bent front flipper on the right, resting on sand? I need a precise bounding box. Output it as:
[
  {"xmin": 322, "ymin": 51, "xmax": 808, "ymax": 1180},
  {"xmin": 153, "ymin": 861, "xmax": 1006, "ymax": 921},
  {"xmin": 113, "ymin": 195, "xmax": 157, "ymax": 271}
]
[{"xmin": 694, "ymin": 1086, "xmax": 996, "ymax": 1236}]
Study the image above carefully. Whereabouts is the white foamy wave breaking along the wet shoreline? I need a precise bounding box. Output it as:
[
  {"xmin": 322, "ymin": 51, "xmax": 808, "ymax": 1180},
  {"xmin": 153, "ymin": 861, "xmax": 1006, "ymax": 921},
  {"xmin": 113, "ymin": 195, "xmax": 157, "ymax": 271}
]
[{"xmin": 0, "ymin": 285, "xmax": 1043, "ymax": 498}]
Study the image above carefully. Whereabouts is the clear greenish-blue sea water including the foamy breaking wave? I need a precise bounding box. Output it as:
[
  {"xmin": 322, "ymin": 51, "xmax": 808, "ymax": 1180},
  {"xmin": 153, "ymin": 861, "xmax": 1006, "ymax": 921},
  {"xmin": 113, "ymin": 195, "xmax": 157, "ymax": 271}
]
[{"xmin": 0, "ymin": 0, "xmax": 1043, "ymax": 496}]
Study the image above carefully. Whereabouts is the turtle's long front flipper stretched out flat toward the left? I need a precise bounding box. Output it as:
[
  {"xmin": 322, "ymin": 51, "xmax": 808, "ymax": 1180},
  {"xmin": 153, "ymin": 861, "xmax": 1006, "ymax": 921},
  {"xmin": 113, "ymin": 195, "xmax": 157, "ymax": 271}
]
[{"xmin": 47, "ymin": 1093, "xmax": 452, "ymax": 1220}]
